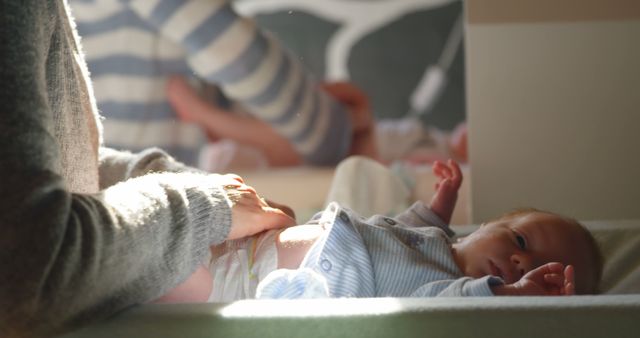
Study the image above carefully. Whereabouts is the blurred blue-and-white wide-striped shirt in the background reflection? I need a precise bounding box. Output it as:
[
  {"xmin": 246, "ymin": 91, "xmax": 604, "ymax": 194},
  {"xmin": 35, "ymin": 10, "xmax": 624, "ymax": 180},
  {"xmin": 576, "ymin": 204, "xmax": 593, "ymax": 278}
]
[{"xmin": 70, "ymin": 0, "xmax": 351, "ymax": 165}]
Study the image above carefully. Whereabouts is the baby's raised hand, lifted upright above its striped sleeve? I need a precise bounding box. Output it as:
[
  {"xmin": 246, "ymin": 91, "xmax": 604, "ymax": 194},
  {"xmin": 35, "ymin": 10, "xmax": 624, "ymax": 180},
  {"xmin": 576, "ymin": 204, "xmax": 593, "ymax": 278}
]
[{"xmin": 429, "ymin": 159, "xmax": 462, "ymax": 224}]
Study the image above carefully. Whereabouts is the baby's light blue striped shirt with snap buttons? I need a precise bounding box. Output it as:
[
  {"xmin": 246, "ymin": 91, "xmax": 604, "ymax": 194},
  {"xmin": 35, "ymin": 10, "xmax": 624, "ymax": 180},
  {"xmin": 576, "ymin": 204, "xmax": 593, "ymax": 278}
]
[{"xmin": 257, "ymin": 202, "xmax": 502, "ymax": 299}]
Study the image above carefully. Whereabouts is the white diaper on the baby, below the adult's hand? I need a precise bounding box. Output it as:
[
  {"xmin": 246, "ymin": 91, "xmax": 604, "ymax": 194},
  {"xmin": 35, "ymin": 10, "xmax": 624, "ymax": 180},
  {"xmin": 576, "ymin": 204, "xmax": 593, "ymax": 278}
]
[{"xmin": 208, "ymin": 230, "xmax": 280, "ymax": 302}]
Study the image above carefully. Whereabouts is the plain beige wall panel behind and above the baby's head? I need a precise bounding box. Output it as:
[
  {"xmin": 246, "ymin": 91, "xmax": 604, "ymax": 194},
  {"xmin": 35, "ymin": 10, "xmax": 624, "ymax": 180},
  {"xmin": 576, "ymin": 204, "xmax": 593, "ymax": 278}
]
[{"xmin": 466, "ymin": 0, "xmax": 640, "ymax": 222}]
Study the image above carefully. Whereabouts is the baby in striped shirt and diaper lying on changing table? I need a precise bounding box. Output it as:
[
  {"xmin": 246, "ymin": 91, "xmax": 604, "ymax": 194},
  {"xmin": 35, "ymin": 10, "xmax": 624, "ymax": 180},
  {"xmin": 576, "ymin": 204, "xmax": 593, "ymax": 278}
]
[{"xmin": 159, "ymin": 160, "xmax": 602, "ymax": 302}]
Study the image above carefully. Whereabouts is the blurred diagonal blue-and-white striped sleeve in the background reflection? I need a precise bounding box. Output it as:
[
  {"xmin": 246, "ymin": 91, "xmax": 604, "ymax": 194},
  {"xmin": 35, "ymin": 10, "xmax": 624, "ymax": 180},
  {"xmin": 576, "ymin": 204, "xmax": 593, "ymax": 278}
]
[{"xmin": 125, "ymin": 0, "xmax": 352, "ymax": 165}]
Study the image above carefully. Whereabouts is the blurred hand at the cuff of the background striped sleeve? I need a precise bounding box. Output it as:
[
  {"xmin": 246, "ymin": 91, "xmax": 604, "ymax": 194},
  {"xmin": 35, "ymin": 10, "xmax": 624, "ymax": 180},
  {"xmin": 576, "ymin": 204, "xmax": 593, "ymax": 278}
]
[{"xmin": 323, "ymin": 82, "xmax": 378, "ymax": 160}]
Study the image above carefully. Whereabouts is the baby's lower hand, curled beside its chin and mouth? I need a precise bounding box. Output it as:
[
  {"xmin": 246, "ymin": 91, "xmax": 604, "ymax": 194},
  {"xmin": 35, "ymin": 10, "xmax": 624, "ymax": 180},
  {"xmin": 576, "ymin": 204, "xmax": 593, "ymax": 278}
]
[{"xmin": 492, "ymin": 263, "xmax": 575, "ymax": 296}]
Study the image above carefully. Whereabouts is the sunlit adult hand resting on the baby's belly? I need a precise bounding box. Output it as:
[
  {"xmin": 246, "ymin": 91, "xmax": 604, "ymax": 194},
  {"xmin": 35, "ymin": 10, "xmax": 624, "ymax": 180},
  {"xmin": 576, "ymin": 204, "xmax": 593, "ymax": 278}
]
[{"xmin": 225, "ymin": 183, "xmax": 296, "ymax": 239}]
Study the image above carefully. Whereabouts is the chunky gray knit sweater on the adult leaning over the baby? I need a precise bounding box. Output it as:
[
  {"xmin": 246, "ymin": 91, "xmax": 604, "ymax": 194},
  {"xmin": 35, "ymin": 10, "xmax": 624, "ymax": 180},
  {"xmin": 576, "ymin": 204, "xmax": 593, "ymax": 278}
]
[{"xmin": 0, "ymin": 0, "xmax": 231, "ymax": 337}]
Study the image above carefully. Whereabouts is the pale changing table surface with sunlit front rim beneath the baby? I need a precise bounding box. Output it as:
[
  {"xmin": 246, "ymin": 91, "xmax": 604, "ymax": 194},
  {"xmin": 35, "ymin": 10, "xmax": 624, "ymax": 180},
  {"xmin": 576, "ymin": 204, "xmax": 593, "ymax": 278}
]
[{"xmin": 65, "ymin": 220, "xmax": 640, "ymax": 338}]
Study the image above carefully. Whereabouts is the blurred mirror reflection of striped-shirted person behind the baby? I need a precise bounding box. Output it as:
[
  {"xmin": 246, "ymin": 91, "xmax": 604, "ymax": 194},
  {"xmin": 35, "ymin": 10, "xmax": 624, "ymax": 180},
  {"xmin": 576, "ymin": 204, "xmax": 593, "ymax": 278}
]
[{"xmin": 70, "ymin": 0, "xmax": 467, "ymax": 223}]
